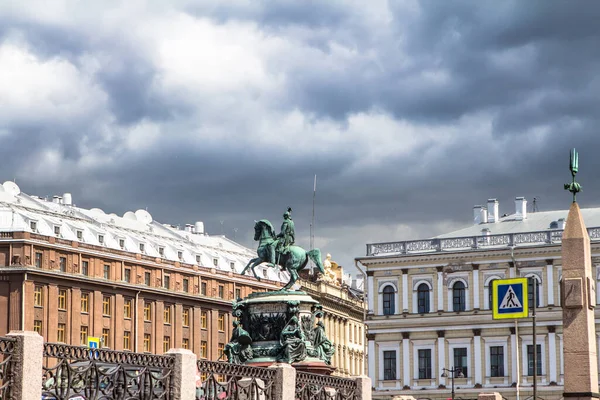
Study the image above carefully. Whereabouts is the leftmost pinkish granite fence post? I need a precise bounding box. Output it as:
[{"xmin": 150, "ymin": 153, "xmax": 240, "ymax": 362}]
[{"xmin": 6, "ymin": 331, "xmax": 44, "ymax": 400}]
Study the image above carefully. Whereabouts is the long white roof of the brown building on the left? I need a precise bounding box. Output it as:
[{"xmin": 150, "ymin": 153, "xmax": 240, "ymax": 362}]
[{"xmin": 0, "ymin": 182, "xmax": 289, "ymax": 282}]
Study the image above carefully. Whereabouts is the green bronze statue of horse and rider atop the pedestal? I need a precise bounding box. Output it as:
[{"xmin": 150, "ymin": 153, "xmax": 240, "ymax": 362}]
[{"xmin": 242, "ymin": 208, "xmax": 325, "ymax": 290}]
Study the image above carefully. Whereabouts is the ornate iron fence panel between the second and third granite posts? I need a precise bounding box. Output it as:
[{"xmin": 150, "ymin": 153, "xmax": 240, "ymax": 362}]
[{"xmin": 196, "ymin": 360, "xmax": 275, "ymax": 400}]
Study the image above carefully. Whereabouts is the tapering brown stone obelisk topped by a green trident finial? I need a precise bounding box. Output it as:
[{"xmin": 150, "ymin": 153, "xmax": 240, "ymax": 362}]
[{"xmin": 562, "ymin": 149, "xmax": 600, "ymax": 400}]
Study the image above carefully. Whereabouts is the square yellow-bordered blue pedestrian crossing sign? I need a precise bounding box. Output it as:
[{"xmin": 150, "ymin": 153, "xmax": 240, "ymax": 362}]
[{"xmin": 492, "ymin": 278, "xmax": 529, "ymax": 319}]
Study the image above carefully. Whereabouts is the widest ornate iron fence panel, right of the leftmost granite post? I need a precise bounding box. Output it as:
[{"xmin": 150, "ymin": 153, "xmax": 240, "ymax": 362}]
[{"xmin": 42, "ymin": 343, "xmax": 175, "ymax": 400}]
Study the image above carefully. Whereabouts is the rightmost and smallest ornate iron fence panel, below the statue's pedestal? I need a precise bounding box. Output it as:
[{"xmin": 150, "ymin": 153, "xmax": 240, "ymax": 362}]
[{"xmin": 296, "ymin": 371, "xmax": 358, "ymax": 400}]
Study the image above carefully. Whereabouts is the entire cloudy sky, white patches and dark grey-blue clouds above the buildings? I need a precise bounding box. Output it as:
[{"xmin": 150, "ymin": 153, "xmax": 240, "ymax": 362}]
[{"xmin": 0, "ymin": 0, "xmax": 600, "ymax": 274}]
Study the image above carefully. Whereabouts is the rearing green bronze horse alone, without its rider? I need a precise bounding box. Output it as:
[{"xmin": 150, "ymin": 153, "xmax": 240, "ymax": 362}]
[{"xmin": 242, "ymin": 219, "xmax": 325, "ymax": 290}]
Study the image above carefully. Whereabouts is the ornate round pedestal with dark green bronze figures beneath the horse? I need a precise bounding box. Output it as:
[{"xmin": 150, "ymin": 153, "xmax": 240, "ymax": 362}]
[{"xmin": 225, "ymin": 291, "xmax": 334, "ymax": 375}]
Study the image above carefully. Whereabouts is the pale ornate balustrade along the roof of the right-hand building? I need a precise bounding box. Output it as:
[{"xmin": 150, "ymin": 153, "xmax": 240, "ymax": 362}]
[{"xmin": 367, "ymin": 227, "xmax": 600, "ymax": 256}]
